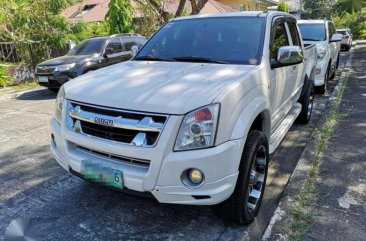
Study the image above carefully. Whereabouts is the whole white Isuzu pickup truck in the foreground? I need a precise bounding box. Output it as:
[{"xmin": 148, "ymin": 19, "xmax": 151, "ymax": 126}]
[{"xmin": 51, "ymin": 12, "xmax": 317, "ymax": 224}]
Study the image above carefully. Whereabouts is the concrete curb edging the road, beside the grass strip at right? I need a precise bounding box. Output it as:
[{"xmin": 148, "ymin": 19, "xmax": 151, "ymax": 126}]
[{"xmin": 262, "ymin": 48, "xmax": 357, "ymax": 241}]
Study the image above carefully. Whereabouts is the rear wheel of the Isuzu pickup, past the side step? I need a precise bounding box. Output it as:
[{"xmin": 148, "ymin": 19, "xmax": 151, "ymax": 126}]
[{"xmin": 296, "ymin": 81, "xmax": 314, "ymax": 125}]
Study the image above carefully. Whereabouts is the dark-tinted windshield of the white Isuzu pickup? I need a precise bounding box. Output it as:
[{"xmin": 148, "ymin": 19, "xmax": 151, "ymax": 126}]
[{"xmin": 134, "ymin": 17, "xmax": 264, "ymax": 64}]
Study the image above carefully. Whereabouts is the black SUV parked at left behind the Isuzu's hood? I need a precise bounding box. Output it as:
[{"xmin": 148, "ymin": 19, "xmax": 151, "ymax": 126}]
[{"xmin": 35, "ymin": 34, "xmax": 146, "ymax": 91}]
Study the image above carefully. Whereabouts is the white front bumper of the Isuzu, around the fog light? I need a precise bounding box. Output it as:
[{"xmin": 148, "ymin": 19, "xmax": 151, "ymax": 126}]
[{"xmin": 51, "ymin": 117, "xmax": 243, "ymax": 205}]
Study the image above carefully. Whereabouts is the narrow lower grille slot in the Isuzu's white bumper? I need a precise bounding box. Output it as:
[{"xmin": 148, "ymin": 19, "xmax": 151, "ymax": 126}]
[{"xmin": 75, "ymin": 144, "xmax": 150, "ymax": 167}]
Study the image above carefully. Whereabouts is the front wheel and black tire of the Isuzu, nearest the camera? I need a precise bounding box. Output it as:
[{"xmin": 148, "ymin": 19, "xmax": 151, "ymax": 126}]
[{"xmin": 215, "ymin": 130, "xmax": 269, "ymax": 225}]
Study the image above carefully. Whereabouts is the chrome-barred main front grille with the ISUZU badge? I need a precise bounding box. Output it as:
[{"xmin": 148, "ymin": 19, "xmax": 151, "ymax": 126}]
[{"xmin": 68, "ymin": 102, "xmax": 168, "ymax": 147}]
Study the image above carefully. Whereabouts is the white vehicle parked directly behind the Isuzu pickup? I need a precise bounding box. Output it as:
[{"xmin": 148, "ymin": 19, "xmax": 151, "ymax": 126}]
[{"xmin": 298, "ymin": 20, "xmax": 342, "ymax": 94}]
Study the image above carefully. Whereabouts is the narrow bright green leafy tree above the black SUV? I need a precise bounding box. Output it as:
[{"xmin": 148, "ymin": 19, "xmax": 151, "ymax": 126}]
[{"xmin": 106, "ymin": 0, "xmax": 132, "ymax": 34}]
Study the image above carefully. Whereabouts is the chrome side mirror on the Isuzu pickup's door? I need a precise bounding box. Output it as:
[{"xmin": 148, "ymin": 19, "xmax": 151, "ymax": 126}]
[{"xmin": 272, "ymin": 46, "xmax": 304, "ymax": 68}]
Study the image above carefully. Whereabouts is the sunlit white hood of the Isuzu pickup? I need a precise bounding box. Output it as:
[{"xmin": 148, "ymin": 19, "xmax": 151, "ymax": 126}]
[{"xmin": 65, "ymin": 61, "xmax": 257, "ymax": 114}]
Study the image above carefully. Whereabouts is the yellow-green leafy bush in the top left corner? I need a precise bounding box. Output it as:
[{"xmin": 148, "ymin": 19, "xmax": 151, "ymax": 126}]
[{"xmin": 0, "ymin": 0, "xmax": 79, "ymax": 48}]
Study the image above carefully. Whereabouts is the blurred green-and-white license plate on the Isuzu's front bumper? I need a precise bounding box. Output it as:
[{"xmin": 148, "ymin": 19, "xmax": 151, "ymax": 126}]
[{"xmin": 81, "ymin": 160, "xmax": 123, "ymax": 189}]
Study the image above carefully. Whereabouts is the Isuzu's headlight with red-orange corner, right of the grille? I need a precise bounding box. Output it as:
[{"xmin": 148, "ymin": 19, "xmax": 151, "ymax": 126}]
[{"xmin": 174, "ymin": 104, "xmax": 219, "ymax": 151}]
